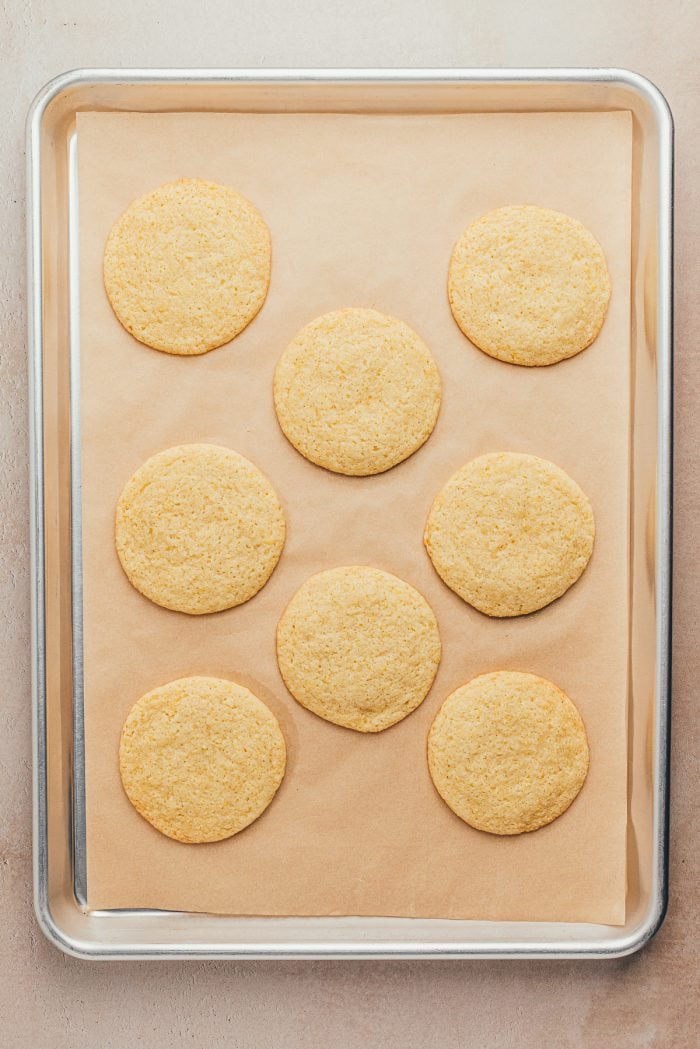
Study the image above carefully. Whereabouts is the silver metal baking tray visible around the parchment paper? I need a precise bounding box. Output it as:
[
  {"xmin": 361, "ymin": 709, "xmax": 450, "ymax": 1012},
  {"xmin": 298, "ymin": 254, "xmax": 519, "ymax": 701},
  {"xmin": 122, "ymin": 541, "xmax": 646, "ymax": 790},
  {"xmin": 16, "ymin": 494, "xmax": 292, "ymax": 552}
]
[{"xmin": 27, "ymin": 69, "xmax": 673, "ymax": 958}]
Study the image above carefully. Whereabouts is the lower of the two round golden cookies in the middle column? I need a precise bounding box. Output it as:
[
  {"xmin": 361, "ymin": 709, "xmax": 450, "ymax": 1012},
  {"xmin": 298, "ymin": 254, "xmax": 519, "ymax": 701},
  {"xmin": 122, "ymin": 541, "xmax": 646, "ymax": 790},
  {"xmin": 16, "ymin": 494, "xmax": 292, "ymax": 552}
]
[{"xmin": 277, "ymin": 565, "xmax": 440, "ymax": 732}]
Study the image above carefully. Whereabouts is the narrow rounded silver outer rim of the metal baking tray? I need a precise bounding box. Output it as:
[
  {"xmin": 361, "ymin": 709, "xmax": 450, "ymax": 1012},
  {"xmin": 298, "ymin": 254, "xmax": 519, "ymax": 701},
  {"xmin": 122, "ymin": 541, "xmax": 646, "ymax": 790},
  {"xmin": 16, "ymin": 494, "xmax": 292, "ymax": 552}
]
[{"xmin": 26, "ymin": 67, "xmax": 674, "ymax": 959}]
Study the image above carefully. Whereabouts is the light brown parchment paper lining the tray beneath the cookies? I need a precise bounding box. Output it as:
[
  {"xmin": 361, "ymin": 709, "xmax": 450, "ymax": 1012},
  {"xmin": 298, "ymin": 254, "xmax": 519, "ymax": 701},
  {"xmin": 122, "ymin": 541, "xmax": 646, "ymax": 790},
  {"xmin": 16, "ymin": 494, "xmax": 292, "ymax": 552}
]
[{"xmin": 78, "ymin": 112, "xmax": 631, "ymax": 924}]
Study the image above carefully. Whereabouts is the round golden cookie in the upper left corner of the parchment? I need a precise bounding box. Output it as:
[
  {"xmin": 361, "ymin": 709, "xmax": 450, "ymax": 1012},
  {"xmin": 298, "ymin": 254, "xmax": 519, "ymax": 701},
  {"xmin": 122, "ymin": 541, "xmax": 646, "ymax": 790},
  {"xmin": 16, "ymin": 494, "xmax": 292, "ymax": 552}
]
[{"xmin": 104, "ymin": 178, "xmax": 272, "ymax": 355}]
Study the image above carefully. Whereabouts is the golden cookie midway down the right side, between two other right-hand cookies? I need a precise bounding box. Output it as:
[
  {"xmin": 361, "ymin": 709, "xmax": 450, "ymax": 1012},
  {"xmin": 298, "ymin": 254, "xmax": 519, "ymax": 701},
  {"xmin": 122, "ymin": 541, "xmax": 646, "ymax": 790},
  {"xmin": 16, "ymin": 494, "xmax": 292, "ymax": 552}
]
[{"xmin": 425, "ymin": 452, "xmax": 595, "ymax": 617}]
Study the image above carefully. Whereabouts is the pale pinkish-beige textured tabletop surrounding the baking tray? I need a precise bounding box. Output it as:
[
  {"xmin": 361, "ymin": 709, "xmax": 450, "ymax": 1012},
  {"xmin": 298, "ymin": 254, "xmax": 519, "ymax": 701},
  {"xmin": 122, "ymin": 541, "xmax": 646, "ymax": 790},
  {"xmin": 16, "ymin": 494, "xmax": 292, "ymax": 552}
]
[{"xmin": 0, "ymin": 0, "xmax": 700, "ymax": 1049}]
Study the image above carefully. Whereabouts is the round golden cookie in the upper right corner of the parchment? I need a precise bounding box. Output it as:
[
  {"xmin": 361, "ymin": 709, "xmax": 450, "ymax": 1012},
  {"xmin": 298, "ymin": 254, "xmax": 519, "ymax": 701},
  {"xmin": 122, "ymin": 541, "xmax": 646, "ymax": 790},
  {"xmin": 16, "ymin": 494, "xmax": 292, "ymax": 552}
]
[{"xmin": 448, "ymin": 205, "xmax": 611, "ymax": 366}]
